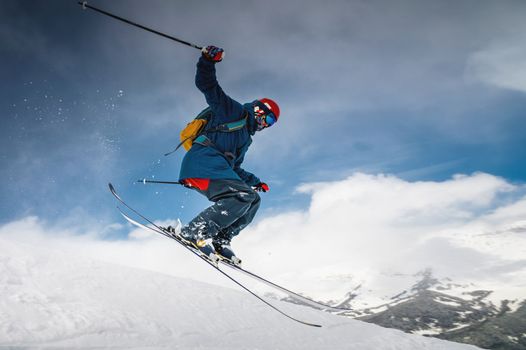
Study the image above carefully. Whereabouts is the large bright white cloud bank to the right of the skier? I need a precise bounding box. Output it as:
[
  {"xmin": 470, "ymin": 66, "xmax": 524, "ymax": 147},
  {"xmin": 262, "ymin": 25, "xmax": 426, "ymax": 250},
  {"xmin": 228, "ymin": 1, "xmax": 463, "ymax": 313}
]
[{"xmin": 234, "ymin": 173, "xmax": 526, "ymax": 299}]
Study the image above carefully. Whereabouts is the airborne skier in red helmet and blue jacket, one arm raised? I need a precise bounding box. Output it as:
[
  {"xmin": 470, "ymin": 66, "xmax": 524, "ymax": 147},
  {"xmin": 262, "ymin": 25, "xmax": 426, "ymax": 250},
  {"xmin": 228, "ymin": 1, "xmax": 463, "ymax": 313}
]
[{"xmin": 168, "ymin": 46, "xmax": 279, "ymax": 264}]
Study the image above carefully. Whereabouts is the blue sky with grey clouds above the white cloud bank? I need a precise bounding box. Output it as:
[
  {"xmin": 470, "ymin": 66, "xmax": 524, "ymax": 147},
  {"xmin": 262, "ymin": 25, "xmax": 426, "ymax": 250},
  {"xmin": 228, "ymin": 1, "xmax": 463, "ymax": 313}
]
[{"xmin": 0, "ymin": 0, "xmax": 526, "ymax": 235}]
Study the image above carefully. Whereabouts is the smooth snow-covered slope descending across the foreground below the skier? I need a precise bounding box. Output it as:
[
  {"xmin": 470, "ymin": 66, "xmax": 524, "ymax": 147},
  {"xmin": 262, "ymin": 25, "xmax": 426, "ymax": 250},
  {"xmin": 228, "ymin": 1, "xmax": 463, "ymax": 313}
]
[{"xmin": 0, "ymin": 237, "xmax": 482, "ymax": 350}]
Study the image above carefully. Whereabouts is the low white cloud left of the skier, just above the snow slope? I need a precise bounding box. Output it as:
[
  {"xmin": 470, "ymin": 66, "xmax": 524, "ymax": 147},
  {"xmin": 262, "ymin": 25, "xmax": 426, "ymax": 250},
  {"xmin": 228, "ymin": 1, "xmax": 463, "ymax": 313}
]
[{"xmin": 0, "ymin": 216, "xmax": 232, "ymax": 287}]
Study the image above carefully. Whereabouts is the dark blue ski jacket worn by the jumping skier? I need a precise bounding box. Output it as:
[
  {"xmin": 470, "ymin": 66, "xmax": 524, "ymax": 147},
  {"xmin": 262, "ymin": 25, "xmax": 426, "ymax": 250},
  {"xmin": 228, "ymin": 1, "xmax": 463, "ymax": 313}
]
[{"xmin": 179, "ymin": 56, "xmax": 261, "ymax": 186}]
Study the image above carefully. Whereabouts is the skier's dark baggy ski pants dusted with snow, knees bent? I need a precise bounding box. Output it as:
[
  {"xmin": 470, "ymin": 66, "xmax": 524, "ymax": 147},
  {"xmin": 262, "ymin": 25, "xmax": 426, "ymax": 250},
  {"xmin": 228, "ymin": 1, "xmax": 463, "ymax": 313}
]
[{"xmin": 182, "ymin": 179, "xmax": 261, "ymax": 243}]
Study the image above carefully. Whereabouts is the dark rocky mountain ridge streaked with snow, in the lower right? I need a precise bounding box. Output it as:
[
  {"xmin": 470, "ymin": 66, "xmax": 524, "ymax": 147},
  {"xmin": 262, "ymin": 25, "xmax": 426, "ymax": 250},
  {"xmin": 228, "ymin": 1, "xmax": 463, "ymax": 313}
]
[{"xmin": 355, "ymin": 270, "xmax": 526, "ymax": 350}]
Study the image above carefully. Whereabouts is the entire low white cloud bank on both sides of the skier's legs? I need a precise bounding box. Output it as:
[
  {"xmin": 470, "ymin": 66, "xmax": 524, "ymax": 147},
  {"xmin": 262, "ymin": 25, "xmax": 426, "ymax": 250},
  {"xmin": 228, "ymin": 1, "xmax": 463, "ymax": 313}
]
[{"xmin": 0, "ymin": 173, "xmax": 526, "ymax": 300}]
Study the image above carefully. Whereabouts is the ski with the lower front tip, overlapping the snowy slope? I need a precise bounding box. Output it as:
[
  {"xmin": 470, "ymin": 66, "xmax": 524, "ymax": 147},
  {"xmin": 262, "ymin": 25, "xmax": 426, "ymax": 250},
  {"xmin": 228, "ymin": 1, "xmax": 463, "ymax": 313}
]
[{"xmin": 108, "ymin": 183, "xmax": 321, "ymax": 327}]
